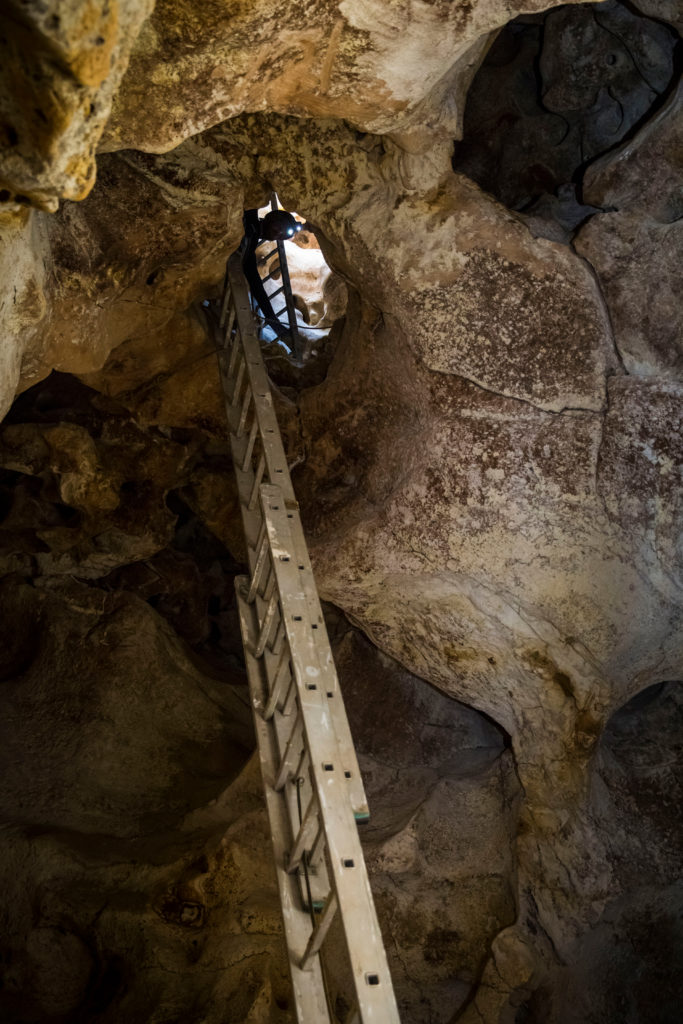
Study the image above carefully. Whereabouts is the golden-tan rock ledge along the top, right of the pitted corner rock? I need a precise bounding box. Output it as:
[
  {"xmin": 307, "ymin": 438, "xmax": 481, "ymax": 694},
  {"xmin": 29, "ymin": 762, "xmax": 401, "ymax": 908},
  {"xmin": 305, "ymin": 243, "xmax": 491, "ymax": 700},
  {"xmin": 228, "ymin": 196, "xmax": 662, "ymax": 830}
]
[{"xmin": 97, "ymin": 0, "xmax": 565, "ymax": 153}]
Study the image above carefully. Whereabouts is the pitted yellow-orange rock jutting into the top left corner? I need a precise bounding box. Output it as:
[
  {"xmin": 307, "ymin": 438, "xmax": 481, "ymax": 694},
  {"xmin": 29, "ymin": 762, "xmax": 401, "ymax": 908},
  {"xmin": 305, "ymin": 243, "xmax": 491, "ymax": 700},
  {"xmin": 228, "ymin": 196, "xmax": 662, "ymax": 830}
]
[{"xmin": 0, "ymin": 0, "xmax": 154, "ymax": 214}]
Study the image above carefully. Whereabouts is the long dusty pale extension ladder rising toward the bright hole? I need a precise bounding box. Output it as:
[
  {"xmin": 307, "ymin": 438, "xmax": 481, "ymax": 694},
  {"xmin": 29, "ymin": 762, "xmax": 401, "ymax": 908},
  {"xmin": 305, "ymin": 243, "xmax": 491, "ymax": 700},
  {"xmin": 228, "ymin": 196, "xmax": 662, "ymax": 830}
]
[{"xmin": 217, "ymin": 253, "xmax": 399, "ymax": 1024}]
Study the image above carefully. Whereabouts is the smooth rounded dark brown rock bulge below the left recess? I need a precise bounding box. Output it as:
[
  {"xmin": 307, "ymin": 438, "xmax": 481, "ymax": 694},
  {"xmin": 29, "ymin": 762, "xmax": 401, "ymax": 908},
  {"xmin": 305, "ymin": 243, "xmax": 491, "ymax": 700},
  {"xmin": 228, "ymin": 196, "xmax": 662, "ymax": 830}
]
[{"xmin": 2, "ymin": 580, "xmax": 251, "ymax": 838}]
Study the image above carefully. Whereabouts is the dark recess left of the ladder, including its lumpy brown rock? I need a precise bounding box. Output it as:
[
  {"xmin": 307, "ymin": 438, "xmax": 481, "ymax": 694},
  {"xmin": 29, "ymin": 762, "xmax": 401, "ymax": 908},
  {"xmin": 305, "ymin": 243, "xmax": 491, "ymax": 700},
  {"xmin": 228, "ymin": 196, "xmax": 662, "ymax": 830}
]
[{"xmin": 0, "ymin": 373, "xmax": 246, "ymax": 682}]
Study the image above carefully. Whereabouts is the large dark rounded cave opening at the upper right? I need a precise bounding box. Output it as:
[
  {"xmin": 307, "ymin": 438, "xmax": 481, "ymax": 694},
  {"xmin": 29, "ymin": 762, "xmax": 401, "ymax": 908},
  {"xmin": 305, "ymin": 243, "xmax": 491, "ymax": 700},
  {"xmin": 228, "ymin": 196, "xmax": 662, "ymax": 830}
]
[{"xmin": 453, "ymin": 0, "xmax": 681, "ymax": 235}]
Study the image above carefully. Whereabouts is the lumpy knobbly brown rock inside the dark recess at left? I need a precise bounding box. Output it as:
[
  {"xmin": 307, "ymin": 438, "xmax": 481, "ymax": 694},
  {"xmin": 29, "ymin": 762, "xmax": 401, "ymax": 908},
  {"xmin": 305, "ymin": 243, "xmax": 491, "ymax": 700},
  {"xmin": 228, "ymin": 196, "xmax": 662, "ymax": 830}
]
[{"xmin": 0, "ymin": 393, "xmax": 191, "ymax": 578}]
